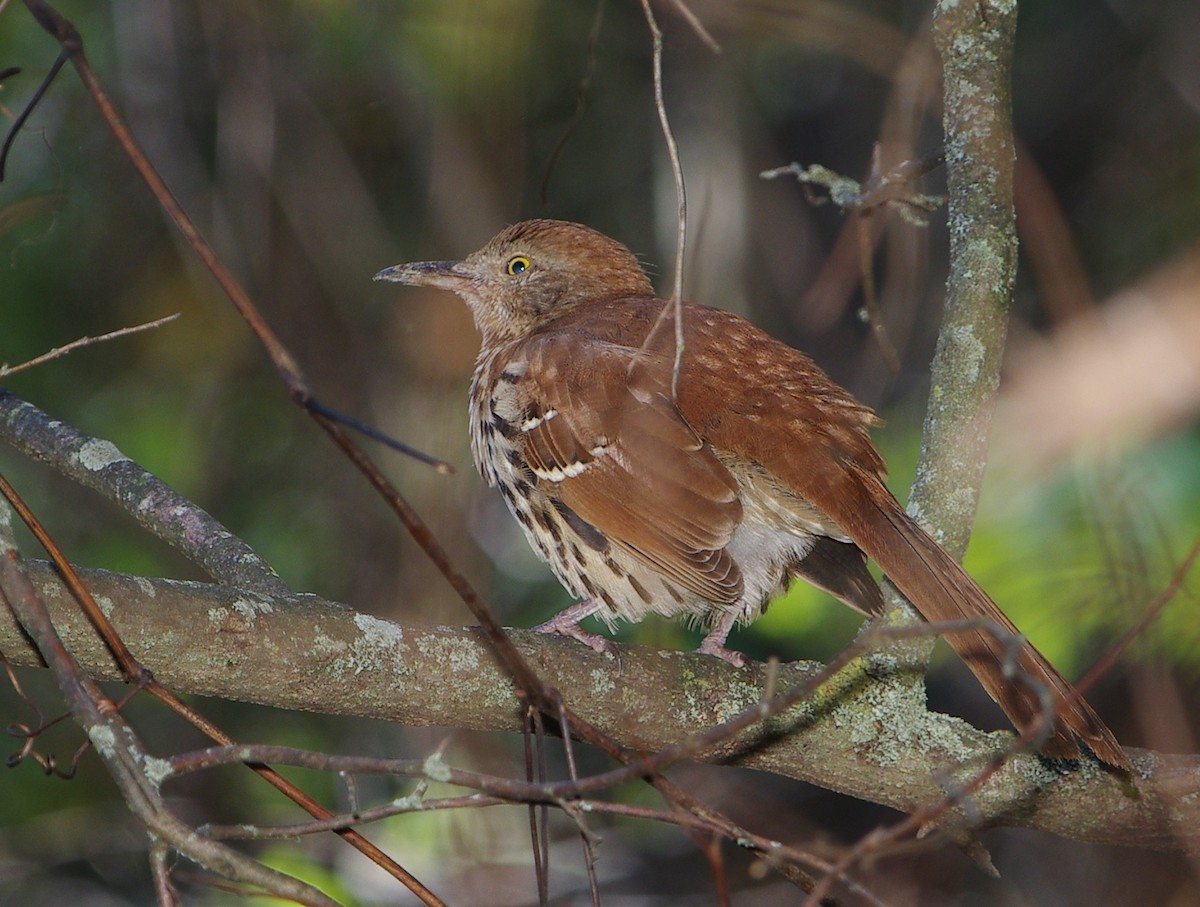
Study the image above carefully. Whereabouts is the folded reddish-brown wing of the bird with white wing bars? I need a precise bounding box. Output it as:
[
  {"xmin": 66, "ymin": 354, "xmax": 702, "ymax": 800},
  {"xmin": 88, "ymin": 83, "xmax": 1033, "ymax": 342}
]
[{"xmin": 515, "ymin": 332, "xmax": 742, "ymax": 605}]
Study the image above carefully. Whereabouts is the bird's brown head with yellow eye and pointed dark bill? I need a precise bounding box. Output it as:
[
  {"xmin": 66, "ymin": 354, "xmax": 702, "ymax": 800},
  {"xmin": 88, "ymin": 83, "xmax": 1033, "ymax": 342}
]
[{"xmin": 374, "ymin": 220, "xmax": 654, "ymax": 346}]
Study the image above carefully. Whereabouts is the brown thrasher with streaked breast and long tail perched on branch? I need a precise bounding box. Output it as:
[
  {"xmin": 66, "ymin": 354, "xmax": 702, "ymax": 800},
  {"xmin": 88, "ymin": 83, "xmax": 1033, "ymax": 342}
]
[{"xmin": 376, "ymin": 220, "xmax": 1129, "ymax": 768}]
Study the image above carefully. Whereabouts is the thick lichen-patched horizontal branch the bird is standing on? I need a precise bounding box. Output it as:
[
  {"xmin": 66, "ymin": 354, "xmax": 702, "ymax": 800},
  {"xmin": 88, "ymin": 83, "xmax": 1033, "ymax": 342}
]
[{"xmin": 0, "ymin": 564, "xmax": 1200, "ymax": 849}]
